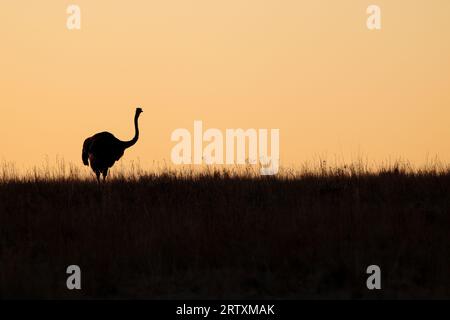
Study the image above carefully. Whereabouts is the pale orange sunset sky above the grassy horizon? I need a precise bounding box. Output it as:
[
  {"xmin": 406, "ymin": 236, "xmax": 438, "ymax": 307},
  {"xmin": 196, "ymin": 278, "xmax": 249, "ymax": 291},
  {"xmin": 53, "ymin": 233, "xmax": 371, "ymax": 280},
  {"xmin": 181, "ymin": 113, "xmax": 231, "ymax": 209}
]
[{"xmin": 0, "ymin": 0, "xmax": 450, "ymax": 172}]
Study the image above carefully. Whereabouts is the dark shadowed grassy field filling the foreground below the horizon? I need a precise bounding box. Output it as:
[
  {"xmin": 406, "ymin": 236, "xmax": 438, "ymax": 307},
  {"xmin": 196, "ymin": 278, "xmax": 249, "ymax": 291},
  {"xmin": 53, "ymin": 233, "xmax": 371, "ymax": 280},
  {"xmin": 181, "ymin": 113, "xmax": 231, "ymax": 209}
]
[{"xmin": 0, "ymin": 171, "xmax": 450, "ymax": 299}]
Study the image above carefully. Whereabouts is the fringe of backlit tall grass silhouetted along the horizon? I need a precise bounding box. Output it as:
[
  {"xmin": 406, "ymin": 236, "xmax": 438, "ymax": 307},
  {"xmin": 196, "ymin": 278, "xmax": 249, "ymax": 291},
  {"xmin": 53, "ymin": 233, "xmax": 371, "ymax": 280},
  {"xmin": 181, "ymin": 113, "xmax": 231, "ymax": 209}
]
[{"xmin": 0, "ymin": 157, "xmax": 450, "ymax": 183}]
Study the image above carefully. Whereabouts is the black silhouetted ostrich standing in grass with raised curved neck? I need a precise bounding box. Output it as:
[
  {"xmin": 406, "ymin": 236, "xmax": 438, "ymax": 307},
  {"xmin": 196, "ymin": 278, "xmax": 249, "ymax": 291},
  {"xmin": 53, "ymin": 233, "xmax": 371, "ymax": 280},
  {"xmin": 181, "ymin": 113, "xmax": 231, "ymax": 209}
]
[{"xmin": 81, "ymin": 108, "xmax": 144, "ymax": 182}]
